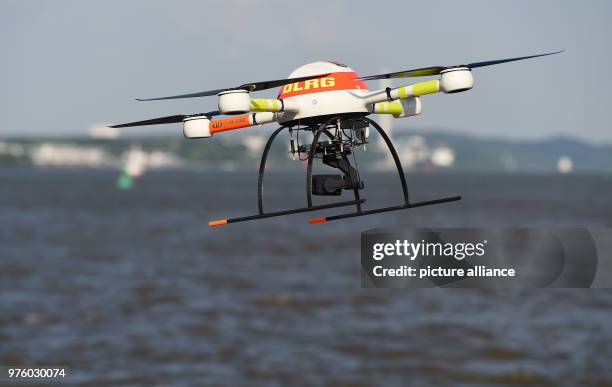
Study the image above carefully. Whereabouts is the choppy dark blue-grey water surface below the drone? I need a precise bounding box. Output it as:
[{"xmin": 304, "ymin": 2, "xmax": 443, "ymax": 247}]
[{"xmin": 0, "ymin": 170, "xmax": 612, "ymax": 386}]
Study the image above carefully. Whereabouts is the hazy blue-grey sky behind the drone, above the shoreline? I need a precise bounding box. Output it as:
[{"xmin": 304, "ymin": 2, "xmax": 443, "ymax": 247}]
[{"xmin": 0, "ymin": 0, "xmax": 612, "ymax": 143}]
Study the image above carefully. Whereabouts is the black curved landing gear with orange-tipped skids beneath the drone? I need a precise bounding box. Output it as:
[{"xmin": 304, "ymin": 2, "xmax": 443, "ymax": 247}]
[{"xmin": 208, "ymin": 116, "xmax": 461, "ymax": 226}]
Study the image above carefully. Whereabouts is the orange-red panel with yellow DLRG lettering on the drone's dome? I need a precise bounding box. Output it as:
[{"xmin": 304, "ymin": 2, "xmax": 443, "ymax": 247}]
[{"xmin": 278, "ymin": 71, "xmax": 368, "ymax": 99}]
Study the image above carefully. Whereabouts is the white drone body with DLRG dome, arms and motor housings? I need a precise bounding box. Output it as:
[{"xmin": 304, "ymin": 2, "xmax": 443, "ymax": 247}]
[{"xmin": 183, "ymin": 61, "xmax": 474, "ymax": 138}]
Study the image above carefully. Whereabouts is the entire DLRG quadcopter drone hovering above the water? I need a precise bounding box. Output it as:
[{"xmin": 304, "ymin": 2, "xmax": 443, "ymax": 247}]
[{"xmin": 111, "ymin": 50, "xmax": 563, "ymax": 226}]
